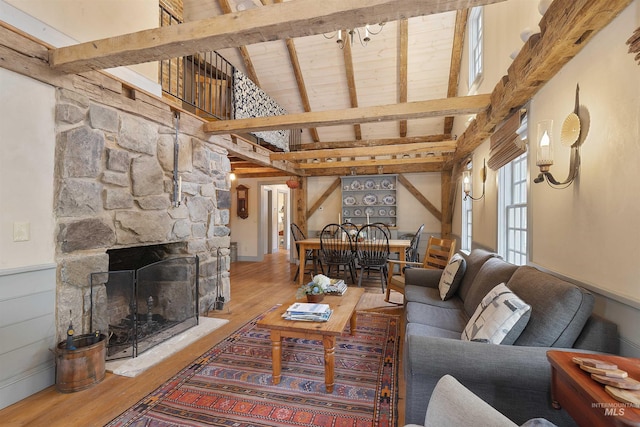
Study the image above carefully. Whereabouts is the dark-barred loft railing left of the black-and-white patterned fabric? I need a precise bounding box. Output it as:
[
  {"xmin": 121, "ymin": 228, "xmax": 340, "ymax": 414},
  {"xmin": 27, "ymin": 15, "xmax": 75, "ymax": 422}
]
[{"xmin": 160, "ymin": 5, "xmax": 234, "ymax": 120}]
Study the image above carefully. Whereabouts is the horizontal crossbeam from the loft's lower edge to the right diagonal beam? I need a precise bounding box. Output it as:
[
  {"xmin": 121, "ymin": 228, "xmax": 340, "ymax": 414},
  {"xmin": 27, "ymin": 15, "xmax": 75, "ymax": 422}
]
[{"xmin": 203, "ymin": 95, "xmax": 489, "ymax": 135}]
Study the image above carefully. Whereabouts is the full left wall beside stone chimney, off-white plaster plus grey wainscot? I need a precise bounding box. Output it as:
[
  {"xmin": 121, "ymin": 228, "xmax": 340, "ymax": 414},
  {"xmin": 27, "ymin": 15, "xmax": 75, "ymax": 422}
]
[{"xmin": 0, "ymin": 68, "xmax": 56, "ymax": 408}]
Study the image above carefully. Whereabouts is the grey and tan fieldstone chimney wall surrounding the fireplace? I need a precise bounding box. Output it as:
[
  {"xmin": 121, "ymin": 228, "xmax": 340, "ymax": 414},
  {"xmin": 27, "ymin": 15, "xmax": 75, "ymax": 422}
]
[{"xmin": 54, "ymin": 89, "xmax": 231, "ymax": 339}]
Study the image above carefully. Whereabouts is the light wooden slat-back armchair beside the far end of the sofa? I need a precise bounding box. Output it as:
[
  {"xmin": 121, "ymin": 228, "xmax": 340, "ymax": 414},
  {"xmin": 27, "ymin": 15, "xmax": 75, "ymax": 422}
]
[{"xmin": 384, "ymin": 236, "xmax": 456, "ymax": 302}]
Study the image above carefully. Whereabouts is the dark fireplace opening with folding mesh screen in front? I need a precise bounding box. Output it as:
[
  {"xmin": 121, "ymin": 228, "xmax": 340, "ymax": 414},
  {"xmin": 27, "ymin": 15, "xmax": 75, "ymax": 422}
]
[{"xmin": 91, "ymin": 244, "xmax": 199, "ymax": 360}]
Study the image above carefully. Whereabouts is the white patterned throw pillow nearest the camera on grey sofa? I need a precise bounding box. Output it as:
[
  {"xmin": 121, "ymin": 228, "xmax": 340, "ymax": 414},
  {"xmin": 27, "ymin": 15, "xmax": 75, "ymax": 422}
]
[{"xmin": 461, "ymin": 283, "xmax": 531, "ymax": 344}]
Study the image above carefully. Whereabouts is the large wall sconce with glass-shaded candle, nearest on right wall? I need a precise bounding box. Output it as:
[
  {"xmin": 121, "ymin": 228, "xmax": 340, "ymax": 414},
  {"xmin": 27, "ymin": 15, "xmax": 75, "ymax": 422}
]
[{"xmin": 533, "ymin": 87, "xmax": 580, "ymax": 188}]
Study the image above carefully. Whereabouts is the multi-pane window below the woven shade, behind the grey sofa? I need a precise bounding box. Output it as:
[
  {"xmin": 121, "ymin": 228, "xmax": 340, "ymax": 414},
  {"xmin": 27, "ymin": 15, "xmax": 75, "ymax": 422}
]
[{"xmin": 498, "ymin": 153, "xmax": 527, "ymax": 265}]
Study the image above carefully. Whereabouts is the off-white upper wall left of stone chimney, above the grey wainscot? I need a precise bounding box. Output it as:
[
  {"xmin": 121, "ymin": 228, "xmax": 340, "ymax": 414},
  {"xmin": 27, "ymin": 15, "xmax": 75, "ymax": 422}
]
[{"xmin": 0, "ymin": 68, "xmax": 55, "ymax": 270}]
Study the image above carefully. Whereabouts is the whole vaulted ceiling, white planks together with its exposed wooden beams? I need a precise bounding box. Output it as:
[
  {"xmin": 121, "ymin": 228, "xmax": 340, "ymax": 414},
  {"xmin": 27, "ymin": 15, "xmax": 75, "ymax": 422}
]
[{"xmin": 50, "ymin": 0, "xmax": 631, "ymax": 177}]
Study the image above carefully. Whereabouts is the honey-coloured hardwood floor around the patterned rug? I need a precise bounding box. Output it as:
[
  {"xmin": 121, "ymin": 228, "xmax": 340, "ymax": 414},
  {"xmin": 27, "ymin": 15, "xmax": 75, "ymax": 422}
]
[{"xmin": 0, "ymin": 251, "xmax": 404, "ymax": 427}]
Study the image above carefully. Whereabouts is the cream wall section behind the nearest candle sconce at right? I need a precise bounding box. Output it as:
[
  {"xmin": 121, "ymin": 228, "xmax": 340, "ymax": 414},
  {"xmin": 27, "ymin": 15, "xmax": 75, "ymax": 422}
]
[{"xmin": 529, "ymin": 1, "xmax": 640, "ymax": 351}]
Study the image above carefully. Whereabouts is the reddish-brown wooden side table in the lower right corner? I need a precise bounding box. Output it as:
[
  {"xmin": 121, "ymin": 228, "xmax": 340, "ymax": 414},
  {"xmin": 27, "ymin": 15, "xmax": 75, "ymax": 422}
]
[{"xmin": 547, "ymin": 350, "xmax": 640, "ymax": 427}]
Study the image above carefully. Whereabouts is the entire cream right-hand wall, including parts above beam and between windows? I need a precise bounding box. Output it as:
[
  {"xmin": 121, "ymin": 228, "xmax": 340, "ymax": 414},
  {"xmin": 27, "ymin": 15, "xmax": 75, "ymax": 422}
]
[{"xmin": 453, "ymin": 0, "xmax": 640, "ymax": 357}]
